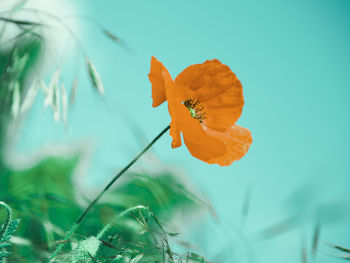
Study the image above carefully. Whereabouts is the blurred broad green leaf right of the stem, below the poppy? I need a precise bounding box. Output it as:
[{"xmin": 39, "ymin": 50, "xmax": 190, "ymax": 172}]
[{"xmin": 103, "ymin": 172, "xmax": 211, "ymax": 220}]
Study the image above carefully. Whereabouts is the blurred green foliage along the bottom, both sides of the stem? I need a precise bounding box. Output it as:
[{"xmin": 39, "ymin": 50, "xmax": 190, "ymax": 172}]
[{"xmin": 0, "ymin": 155, "xmax": 209, "ymax": 262}]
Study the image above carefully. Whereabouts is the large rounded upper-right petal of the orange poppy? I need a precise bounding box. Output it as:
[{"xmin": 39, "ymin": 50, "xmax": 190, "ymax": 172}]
[{"xmin": 174, "ymin": 59, "xmax": 244, "ymax": 131}]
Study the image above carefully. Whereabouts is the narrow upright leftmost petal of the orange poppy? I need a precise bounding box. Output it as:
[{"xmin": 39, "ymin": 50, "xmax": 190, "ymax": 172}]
[{"xmin": 148, "ymin": 56, "xmax": 173, "ymax": 107}]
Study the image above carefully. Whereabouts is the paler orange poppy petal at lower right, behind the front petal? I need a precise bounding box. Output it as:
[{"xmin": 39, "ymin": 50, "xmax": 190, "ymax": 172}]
[{"xmin": 206, "ymin": 125, "xmax": 253, "ymax": 166}]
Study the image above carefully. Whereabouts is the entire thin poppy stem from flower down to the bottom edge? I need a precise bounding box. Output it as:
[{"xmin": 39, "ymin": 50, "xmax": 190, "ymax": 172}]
[{"xmin": 50, "ymin": 125, "xmax": 170, "ymax": 262}]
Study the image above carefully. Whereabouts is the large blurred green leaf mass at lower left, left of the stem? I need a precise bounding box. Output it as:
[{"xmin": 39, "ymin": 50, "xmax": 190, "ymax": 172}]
[{"xmin": 0, "ymin": 154, "xmax": 82, "ymax": 263}]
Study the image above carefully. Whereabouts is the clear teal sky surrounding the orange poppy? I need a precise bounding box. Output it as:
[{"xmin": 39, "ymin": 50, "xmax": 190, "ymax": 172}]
[{"xmin": 19, "ymin": 0, "xmax": 350, "ymax": 263}]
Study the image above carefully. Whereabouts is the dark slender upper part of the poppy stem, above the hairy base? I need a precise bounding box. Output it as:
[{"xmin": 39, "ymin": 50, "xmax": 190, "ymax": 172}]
[{"xmin": 76, "ymin": 125, "xmax": 170, "ymax": 225}]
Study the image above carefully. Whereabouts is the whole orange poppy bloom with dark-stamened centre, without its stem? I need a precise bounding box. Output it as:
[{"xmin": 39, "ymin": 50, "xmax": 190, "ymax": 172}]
[{"xmin": 148, "ymin": 57, "xmax": 252, "ymax": 166}]
